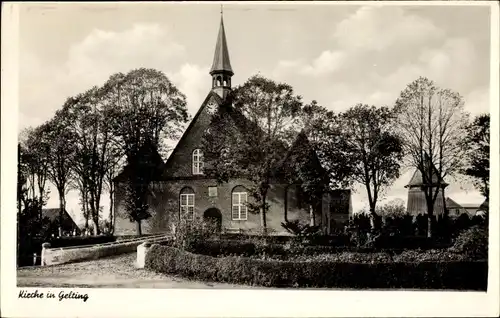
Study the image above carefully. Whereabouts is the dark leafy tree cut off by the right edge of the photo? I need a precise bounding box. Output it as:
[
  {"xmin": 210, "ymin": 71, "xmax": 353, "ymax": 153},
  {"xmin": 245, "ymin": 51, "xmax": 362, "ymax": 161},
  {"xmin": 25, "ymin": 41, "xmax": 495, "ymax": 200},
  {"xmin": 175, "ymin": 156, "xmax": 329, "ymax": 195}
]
[{"xmin": 462, "ymin": 114, "xmax": 490, "ymax": 199}]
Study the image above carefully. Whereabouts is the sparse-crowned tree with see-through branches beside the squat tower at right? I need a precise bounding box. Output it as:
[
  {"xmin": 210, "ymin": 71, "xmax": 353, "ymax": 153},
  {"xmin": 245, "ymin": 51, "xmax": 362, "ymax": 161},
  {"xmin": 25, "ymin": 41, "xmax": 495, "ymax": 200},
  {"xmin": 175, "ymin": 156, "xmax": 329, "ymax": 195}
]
[{"xmin": 396, "ymin": 77, "xmax": 468, "ymax": 237}]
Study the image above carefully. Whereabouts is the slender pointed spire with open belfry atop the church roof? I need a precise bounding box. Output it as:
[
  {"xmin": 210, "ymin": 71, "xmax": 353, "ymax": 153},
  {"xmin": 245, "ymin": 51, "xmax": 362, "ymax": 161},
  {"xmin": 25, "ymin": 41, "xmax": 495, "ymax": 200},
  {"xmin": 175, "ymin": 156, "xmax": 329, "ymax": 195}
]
[{"xmin": 210, "ymin": 7, "xmax": 234, "ymax": 99}]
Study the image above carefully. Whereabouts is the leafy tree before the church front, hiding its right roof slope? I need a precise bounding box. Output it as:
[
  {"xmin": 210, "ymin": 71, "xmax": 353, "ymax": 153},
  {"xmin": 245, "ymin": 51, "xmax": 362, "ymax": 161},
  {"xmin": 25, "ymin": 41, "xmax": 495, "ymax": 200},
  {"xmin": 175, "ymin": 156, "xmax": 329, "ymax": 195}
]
[{"xmin": 203, "ymin": 75, "xmax": 302, "ymax": 234}]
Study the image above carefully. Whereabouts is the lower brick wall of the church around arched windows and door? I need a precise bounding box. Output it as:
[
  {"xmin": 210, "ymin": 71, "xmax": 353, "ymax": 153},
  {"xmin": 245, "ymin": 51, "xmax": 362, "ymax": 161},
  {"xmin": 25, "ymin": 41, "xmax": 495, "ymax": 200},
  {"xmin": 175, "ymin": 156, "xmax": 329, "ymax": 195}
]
[{"xmin": 115, "ymin": 179, "xmax": 322, "ymax": 235}]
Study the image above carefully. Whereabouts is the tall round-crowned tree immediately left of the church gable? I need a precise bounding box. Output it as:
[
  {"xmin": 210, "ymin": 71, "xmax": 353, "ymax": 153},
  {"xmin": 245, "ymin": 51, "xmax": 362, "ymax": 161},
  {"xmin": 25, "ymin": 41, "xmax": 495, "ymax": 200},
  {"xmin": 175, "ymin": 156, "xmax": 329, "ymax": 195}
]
[{"xmin": 102, "ymin": 68, "xmax": 188, "ymax": 235}]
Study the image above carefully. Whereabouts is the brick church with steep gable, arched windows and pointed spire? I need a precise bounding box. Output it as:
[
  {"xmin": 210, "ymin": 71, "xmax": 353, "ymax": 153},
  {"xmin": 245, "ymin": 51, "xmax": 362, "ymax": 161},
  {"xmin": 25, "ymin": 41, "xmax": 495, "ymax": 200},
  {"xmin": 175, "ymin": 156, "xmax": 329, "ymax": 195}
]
[{"xmin": 114, "ymin": 12, "xmax": 352, "ymax": 235}]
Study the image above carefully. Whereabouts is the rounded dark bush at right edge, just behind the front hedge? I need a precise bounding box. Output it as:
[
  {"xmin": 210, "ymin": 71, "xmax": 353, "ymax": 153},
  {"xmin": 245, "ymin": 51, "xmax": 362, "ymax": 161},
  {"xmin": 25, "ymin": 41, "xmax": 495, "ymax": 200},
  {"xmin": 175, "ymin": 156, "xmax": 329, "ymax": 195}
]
[{"xmin": 449, "ymin": 226, "xmax": 488, "ymax": 259}]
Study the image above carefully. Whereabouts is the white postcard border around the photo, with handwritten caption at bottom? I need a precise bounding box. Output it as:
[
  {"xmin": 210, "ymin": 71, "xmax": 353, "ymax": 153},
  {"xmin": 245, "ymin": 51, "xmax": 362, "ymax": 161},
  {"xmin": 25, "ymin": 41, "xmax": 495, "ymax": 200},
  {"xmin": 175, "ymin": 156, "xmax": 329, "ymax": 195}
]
[{"xmin": 1, "ymin": 1, "xmax": 499, "ymax": 317}]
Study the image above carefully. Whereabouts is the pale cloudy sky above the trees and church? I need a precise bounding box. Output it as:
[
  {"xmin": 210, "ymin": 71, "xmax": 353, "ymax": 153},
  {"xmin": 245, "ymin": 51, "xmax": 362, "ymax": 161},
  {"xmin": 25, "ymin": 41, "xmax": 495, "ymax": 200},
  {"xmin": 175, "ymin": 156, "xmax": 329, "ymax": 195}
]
[{"xmin": 18, "ymin": 2, "xmax": 490, "ymax": 226}]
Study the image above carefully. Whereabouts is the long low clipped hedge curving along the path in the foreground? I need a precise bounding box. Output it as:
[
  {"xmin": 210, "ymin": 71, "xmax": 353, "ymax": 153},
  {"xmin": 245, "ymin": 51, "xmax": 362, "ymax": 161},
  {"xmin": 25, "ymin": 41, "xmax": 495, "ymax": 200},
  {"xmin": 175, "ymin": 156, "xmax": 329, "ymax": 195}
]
[{"xmin": 145, "ymin": 244, "xmax": 488, "ymax": 290}]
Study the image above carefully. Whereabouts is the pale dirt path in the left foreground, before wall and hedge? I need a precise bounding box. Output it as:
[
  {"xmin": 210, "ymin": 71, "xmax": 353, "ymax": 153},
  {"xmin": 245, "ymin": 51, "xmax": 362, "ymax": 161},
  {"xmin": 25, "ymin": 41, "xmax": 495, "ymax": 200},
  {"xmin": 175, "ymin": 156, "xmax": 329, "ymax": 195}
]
[{"xmin": 17, "ymin": 253, "xmax": 251, "ymax": 288}]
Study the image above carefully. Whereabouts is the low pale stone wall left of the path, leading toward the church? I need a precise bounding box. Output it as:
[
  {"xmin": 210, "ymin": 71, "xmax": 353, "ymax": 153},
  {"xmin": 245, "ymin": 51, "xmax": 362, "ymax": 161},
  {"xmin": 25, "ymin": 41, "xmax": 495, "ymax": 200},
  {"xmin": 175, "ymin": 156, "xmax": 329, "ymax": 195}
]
[{"xmin": 41, "ymin": 234, "xmax": 168, "ymax": 266}]
